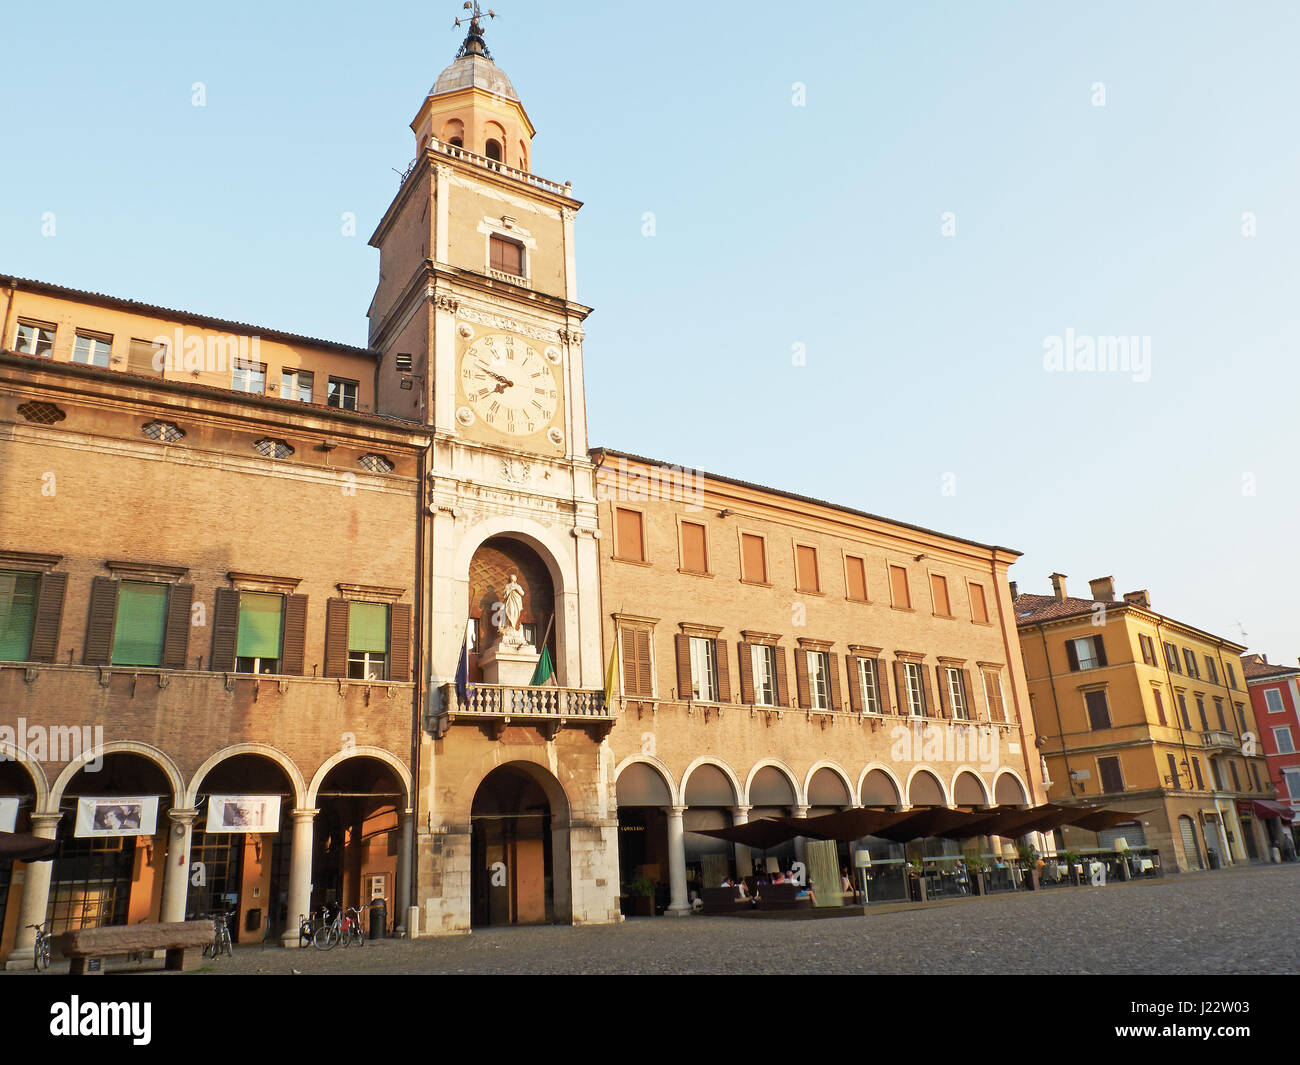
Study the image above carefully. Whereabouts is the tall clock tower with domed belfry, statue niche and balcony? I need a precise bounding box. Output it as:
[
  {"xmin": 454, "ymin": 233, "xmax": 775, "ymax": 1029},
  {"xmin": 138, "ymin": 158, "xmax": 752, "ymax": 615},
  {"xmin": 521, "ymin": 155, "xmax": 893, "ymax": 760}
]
[{"xmin": 369, "ymin": 4, "xmax": 619, "ymax": 932}]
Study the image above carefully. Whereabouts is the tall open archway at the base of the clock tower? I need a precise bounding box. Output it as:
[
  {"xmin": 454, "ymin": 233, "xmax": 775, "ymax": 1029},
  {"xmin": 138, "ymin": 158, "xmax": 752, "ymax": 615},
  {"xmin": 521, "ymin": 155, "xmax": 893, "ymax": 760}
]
[{"xmin": 469, "ymin": 762, "xmax": 568, "ymax": 926}]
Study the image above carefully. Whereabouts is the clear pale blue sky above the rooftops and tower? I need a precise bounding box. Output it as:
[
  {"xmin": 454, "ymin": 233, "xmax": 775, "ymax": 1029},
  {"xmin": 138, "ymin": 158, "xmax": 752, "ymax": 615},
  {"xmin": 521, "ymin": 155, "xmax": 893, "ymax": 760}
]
[{"xmin": 0, "ymin": 0, "xmax": 1300, "ymax": 661}]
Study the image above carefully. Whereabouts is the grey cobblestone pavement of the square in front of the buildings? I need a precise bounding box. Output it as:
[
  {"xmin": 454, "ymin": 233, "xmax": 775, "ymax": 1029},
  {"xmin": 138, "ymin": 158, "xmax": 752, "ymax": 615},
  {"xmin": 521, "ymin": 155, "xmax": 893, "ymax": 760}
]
[{"xmin": 22, "ymin": 863, "xmax": 1300, "ymax": 974}]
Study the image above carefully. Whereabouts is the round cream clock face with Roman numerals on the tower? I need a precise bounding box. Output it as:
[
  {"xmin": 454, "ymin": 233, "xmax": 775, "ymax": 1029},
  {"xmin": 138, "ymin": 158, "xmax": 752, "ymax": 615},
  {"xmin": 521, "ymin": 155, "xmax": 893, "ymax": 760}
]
[{"xmin": 460, "ymin": 333, "xmax": 559, "ymax": 437}]
